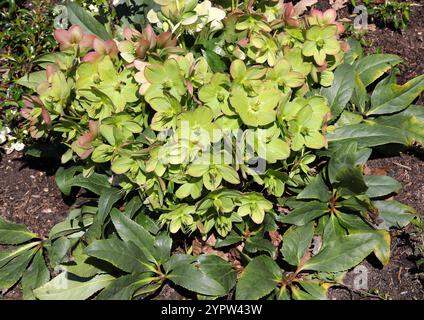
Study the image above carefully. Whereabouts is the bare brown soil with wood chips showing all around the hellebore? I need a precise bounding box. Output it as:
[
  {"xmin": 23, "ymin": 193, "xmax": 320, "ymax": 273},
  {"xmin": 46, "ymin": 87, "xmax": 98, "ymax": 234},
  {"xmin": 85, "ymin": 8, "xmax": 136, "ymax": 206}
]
[{"xmin": 0, "ymin": 0, "xmax": 424, "ymax": 300}]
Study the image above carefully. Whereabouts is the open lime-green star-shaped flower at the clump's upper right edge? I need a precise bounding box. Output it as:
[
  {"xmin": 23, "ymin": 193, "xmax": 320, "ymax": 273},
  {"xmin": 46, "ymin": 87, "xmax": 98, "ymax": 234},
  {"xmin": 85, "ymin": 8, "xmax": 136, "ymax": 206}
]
[{"xmin": 302, "ymin": 25, "xmax": 341, "ymax": 66}]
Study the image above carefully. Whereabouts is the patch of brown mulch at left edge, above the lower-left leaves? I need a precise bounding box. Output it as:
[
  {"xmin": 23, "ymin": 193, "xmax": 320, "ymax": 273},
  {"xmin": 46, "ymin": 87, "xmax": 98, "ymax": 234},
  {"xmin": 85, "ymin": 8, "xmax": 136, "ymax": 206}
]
[{"xmin": 0, "ymin": 152, "xmax": 69, "ymax": 299}]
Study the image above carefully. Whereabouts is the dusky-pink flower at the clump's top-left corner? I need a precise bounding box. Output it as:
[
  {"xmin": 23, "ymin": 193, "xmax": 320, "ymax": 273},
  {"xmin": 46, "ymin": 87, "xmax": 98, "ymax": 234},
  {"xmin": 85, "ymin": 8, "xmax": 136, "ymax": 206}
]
[{"xmin": 53, "ymin": 25, "xmax": 96, "ymax": 51}]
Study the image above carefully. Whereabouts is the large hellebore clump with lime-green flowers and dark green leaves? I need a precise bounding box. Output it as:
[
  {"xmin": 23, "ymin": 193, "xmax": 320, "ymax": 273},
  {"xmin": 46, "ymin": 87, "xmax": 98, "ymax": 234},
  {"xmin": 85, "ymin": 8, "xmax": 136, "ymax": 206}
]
[{"xmin": 0, "ymin": 0, "xmax": 424, "ymax": 299}]
